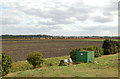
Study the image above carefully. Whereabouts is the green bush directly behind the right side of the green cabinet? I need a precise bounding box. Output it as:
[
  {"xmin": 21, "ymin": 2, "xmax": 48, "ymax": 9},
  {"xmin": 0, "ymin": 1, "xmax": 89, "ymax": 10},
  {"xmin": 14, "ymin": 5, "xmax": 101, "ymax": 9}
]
[{"xmin": 86, "ymin": 46, "xmax": 104, "ymax": 57}]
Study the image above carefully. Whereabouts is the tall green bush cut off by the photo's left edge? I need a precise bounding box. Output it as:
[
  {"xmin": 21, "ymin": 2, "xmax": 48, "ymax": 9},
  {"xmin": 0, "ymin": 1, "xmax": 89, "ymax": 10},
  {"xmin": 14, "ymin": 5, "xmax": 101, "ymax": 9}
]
[{"xmin": 2, "ymin": 53, "xmax": 12, "ymax": 76}]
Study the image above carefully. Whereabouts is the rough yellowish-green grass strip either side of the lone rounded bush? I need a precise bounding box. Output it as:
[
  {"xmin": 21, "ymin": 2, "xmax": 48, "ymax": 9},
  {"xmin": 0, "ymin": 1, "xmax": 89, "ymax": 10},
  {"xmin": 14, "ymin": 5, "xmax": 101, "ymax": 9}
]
[{"xmin": 10, "ymin": 56, "xmax": 69, "ymax": 73}]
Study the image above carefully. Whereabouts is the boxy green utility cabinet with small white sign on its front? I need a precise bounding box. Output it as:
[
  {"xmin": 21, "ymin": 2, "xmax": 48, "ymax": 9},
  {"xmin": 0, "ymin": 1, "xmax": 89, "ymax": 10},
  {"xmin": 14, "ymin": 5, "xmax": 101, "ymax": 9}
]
[{"xmin": 76, "ymin": 51, "xmax": 95, "ymax": 63}]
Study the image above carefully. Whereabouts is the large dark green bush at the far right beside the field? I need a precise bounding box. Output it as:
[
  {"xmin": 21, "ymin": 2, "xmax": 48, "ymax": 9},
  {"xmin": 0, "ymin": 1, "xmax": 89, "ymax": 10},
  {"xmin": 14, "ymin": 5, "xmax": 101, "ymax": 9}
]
[{"xmin": 102, "ymin": 40, "xmax": 120, "ymax": 55}]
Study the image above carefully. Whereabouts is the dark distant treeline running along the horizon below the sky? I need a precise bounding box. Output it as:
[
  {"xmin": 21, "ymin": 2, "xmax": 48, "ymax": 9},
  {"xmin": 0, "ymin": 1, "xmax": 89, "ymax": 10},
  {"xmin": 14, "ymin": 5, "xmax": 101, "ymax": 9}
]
[{"xmin": 0, "ymin": 35, "xmax": 118, "ymax": 39}]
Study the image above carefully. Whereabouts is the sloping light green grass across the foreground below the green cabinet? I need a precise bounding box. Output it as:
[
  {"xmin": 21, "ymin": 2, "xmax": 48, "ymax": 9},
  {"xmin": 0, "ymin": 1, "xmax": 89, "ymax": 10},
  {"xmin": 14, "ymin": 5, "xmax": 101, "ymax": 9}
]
[{"xmin": 7, "ymin": 54, "xmax": 118, "ymax": 77}]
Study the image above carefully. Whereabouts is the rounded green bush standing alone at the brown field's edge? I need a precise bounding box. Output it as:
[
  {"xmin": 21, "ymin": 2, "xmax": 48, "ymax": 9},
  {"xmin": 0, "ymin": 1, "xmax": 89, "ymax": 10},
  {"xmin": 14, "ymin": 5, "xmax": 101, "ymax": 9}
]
[{"xmin": 27, "ymin": 52, "xmax": 44, "ymax": 68}]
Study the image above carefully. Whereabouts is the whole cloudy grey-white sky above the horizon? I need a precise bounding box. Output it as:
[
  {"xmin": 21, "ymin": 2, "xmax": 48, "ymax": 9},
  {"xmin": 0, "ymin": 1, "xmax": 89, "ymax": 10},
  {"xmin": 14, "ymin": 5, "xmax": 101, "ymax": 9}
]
[{"xmin": 0, "ymin": 0, "xmax": 118, "ymax": 36}]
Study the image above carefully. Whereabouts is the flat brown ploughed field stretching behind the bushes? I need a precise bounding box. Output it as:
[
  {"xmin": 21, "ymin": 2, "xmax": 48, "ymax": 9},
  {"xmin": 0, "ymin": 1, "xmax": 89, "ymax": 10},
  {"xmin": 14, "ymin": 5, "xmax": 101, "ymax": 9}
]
[{"xmin": 2, "ymin": 39, "xmax": 103, "ymax": 62}]
